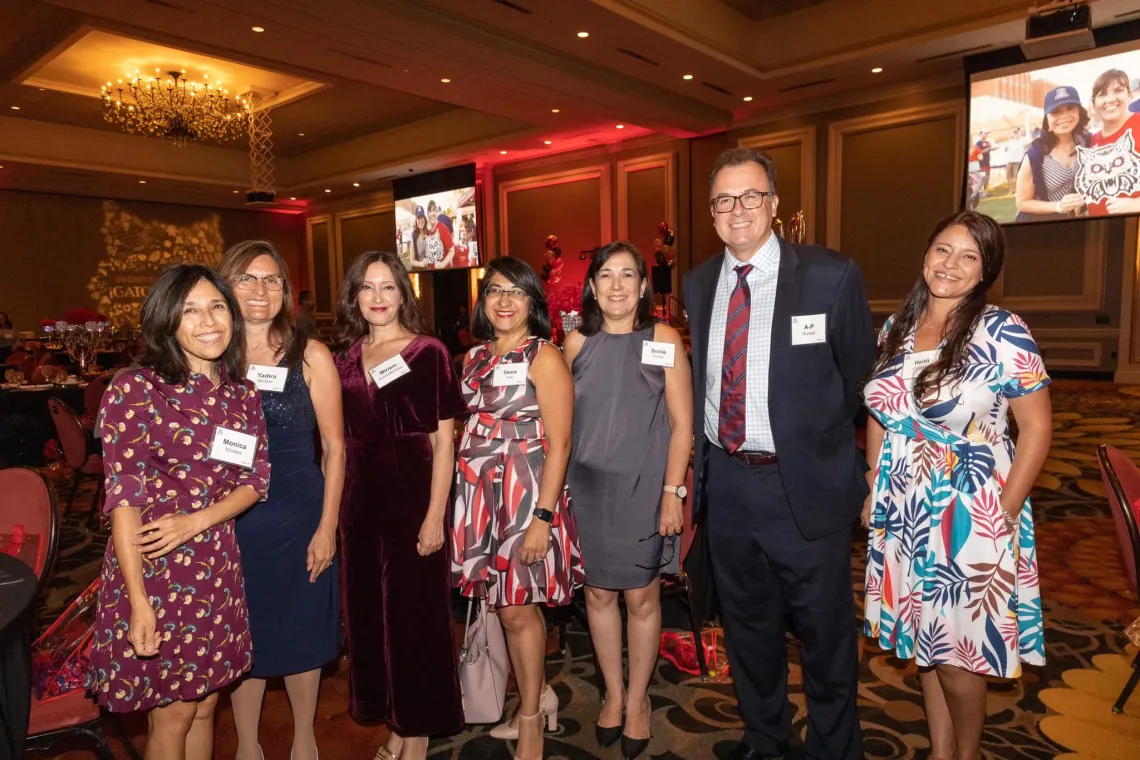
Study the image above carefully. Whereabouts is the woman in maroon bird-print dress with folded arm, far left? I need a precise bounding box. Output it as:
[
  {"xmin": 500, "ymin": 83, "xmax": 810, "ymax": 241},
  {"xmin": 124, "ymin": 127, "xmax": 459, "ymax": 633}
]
[{"xmin": 91, "ymin": 264, "xmax": 269, "ymax": 760}]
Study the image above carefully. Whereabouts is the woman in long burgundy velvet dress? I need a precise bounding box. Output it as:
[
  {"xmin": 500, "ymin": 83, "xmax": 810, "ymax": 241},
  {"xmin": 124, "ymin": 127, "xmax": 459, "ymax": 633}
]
[{"xmin": 333, "ymin": 251, "xmax": 467, "ymax": 760}]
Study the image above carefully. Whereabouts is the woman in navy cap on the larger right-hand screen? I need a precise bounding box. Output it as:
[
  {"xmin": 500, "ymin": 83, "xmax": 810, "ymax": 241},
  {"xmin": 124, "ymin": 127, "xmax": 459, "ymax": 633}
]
[{"xmin": 1015, "ymin": 87, "xmax": 1089, "ymax": 222}]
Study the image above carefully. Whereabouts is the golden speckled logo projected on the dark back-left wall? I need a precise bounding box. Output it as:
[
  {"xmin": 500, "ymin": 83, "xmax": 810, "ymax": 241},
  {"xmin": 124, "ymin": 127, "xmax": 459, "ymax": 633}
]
[{"xmin": 87, "ymin": 201, "xmax": 223, "ymax": 325}]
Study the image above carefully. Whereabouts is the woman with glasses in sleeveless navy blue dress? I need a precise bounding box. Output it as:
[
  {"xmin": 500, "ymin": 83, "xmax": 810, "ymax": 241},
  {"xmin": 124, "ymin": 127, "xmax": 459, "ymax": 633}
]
[{"xmin": 220, "ymin": 240, "xmax": 344, "ymax": 760}]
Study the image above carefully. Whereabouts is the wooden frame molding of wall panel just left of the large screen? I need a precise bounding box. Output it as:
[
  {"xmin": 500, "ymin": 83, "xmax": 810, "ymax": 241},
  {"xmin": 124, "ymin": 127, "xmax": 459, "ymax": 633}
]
[{"xmin": 827, "ymin": 100, "xmax": 966, "ymax": 252}]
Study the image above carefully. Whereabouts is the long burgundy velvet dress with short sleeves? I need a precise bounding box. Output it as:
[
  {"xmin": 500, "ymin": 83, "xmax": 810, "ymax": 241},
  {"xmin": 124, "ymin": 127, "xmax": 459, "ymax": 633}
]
[{"xmin": 335, "ymin": 335, "xmax": 467, "ymax": 736}]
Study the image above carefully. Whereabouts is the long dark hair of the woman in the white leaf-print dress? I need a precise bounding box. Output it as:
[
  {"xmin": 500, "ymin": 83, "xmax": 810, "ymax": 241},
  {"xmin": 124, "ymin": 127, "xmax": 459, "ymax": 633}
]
[{"xmin": 872, "ymin": 211, "xmax": 1005, "ymax": 399}]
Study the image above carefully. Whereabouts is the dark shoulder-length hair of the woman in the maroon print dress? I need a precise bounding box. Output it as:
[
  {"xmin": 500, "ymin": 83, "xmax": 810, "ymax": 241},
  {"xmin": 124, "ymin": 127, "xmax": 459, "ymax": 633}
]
[{"xmin": 135, "ymin": 264, "xmax": 245, "ymax": 385}]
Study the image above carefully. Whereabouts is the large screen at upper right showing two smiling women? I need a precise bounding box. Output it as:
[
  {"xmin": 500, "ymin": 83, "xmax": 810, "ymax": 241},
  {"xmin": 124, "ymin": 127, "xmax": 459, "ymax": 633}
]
[{"xmin": 964, "ymin": 40, "xmax": 1140, "ymax": 224}]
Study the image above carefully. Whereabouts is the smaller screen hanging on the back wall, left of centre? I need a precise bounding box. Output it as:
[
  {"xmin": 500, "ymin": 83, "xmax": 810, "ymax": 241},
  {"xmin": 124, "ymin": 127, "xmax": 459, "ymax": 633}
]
[{"xmin": 392, "ymin": 164, "xmax": 482, "ymax": 272}]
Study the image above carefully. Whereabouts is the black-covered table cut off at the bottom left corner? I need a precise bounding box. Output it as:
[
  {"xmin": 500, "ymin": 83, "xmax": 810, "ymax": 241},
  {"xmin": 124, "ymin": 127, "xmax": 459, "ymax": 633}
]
[{"xmin": 0, "ymin": 553, "xmax": 35, "ymax": 760}]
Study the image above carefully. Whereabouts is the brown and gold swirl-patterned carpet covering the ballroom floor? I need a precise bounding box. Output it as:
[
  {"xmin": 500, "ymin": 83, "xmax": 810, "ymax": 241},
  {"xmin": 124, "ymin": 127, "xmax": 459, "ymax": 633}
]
[{"xmin": 22, "ymin": 381, "xmax": 1140, "ymax": 760}]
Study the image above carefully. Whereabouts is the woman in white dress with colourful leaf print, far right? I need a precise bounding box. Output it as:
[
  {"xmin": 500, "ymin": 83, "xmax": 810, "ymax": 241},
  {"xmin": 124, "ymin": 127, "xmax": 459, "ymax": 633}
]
[{"xmin": 863, "ymin": 211, "xmax": 1052, "ymax": 760}]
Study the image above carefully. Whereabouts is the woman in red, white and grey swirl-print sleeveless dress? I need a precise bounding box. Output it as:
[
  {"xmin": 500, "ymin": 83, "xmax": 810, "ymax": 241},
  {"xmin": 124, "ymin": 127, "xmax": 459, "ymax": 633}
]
[{"xmin": 451, "ymin": 256, "xmax": 585, "ymax": 760}]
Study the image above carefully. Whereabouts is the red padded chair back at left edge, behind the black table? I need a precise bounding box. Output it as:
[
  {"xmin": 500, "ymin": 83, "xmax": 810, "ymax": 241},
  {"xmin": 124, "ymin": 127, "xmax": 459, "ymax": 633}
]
[{"xmin": 0, "ymin": 467, "xmax": 59, "ymax": 593}]
